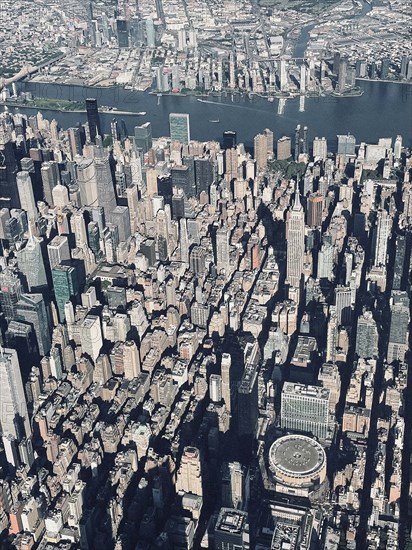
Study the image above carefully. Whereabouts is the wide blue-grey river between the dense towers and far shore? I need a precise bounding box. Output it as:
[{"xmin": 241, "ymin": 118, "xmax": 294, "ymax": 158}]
[{"xmin": 12, "ymin": 81, "xmax": 412, "ymax": 151}]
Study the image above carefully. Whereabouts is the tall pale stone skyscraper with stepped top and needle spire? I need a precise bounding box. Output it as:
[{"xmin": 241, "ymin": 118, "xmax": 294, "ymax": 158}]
[{"xmin": 286, "ymin": 185, "xmax": 305, "ymax": 289}]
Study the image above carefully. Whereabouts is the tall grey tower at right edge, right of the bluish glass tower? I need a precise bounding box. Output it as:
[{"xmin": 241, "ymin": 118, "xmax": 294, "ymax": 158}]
[{"xmin": 386, "ymin": 291, "xmax": 409, "ymax": 364}]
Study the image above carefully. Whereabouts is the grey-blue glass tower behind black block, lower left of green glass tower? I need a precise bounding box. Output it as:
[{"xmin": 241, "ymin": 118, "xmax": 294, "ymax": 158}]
[{"xmin": 16, "ymin": 294, "xmax": 51, "ymax": 356}]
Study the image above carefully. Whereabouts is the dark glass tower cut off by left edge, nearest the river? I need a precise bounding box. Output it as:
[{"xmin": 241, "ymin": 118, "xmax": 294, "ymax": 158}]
[{"xmin": 0, "ymin": 128, "xmax": 20, "ymax": 208}]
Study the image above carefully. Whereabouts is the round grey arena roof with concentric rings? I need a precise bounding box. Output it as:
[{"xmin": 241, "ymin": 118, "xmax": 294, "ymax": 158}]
[{"xmin": 269, "ymin": 435, "xmax": 326, "ymax": 488}]
